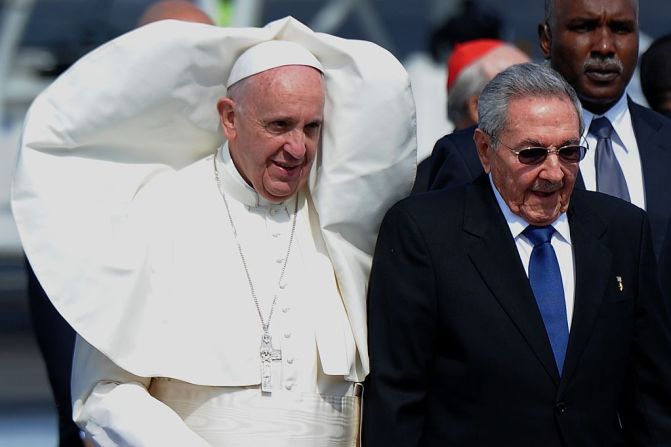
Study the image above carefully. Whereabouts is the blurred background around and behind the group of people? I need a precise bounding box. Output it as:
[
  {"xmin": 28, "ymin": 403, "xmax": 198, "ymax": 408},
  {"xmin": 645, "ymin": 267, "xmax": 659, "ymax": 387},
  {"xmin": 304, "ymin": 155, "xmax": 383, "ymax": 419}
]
[{"xmin": 0, "ymin": 0, "xmax": 671, "ymax": 447}]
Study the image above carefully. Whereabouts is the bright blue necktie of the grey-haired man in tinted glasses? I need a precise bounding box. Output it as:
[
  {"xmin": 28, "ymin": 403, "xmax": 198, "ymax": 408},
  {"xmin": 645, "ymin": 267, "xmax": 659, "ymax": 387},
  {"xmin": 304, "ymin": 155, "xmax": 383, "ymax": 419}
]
[{"xmin": 522, "ymin": 225, "xmax": 568, "ymax": 375}]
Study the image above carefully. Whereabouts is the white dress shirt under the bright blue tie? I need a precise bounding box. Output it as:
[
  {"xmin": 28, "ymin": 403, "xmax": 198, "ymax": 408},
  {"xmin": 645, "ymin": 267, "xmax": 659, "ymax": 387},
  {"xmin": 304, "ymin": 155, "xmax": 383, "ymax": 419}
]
[{"xmin": 489, "ymin": 175, "xmax": 575, "ymax": 331}]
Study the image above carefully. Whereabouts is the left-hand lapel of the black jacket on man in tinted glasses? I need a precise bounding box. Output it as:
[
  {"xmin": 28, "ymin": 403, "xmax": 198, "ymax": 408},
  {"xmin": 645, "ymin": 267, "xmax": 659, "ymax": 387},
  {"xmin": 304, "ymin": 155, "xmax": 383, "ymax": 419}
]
[{"xmin": 464, "ymin": 175, "xmax": 559, "ymax": 385}]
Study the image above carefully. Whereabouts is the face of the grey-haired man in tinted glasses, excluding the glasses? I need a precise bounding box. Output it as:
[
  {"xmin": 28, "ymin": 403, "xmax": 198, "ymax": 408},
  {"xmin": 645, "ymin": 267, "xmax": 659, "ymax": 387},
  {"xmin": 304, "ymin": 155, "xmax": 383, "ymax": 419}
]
[{"xmin": 475, "ymin": 97, "xmax": 580, "ymax": 226}]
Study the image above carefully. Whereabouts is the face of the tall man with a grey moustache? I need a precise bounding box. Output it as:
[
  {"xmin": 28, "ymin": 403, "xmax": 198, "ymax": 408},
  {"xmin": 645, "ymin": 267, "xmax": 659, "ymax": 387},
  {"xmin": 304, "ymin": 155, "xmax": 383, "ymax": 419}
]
[{"xmin": 539, "ymin": 0, "xmax": 638, "ymax": 114}]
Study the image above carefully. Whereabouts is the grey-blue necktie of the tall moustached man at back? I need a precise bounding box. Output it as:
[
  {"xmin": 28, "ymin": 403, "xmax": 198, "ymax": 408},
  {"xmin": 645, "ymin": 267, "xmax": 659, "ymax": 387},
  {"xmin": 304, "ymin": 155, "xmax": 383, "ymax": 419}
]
[{"xmin": 589, "ymin": 117, "xmax": 630, "ymax": 202}]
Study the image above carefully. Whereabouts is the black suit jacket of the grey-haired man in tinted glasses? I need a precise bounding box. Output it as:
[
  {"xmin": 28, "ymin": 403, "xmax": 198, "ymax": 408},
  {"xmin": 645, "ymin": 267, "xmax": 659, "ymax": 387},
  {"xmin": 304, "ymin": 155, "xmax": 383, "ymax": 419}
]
[{"xmin": 363, "ymin": 175, "xmax": 671, "ymax": 447}]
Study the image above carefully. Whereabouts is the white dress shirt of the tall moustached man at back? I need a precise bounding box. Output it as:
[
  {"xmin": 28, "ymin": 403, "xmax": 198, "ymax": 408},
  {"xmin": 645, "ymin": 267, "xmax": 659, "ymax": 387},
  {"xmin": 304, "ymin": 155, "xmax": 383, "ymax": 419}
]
[{"xmin": 580, "ymin": 95, "xmax": 645, "ymax": 209}]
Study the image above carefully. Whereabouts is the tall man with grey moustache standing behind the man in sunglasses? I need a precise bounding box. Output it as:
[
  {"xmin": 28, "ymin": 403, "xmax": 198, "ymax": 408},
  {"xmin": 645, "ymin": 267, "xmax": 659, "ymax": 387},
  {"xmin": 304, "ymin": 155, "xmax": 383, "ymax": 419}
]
[{"xmin": 416, "ymin": 0, "xmax": 671, "ymax": 262}]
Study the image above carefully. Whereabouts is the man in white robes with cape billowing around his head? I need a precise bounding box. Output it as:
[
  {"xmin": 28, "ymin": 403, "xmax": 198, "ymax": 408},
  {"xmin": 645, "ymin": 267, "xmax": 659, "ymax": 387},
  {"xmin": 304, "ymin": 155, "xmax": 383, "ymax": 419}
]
[{"xmin": 12, "ymin": 18, "xmax": 415, "ymax": 447}]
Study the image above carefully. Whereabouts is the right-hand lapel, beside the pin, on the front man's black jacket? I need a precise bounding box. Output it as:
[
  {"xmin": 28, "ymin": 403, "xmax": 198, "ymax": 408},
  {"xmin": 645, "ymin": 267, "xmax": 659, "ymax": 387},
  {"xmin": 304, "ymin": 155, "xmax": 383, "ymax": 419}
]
[{"xmin": 559, "ymin": 192, "xmax": 612, "ymax": 393}]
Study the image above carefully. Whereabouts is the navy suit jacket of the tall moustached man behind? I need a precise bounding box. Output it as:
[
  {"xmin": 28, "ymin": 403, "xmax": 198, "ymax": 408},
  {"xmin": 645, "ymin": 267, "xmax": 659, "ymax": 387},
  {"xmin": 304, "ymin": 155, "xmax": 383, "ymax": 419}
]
[{"xmin": 413, "ymin": 100, "xmax": 671, "ymax": 256}]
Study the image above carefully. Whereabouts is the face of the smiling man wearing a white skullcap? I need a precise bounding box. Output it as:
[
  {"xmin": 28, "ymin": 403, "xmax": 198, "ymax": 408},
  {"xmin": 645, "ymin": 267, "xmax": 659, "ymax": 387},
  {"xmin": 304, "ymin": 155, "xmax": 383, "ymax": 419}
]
[{"xmin": 218, "ymin": 65, "xmax": 325, "ymax": 202}]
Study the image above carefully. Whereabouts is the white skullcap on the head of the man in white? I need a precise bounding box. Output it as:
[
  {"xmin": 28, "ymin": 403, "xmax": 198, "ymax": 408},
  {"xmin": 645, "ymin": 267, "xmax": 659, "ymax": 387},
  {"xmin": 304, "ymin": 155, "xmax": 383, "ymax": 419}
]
[{"xmin": 226, "ymin": 40, "xmax": 324, "ymax": 87}]
